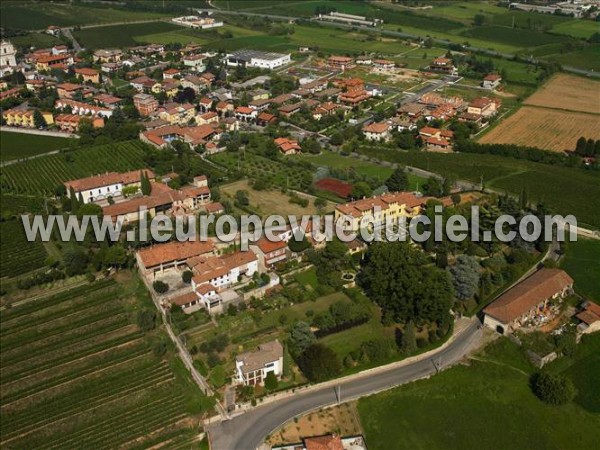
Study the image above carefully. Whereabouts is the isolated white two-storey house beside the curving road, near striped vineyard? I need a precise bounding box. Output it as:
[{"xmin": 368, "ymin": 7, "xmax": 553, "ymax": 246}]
[{"xmin": 234, "ymin": 340, "xmax": 283, "ymax": 386}]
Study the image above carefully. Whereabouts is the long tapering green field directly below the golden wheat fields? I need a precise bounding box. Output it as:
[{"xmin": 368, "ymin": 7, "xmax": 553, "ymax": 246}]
[{"xmin": 359, "ymin": 147, "xmax": 600, "ymax": 228}]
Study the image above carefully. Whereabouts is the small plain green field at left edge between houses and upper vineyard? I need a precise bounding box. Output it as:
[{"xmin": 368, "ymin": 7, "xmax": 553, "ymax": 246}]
[{"xmin": 0, "ymin": 131, "xmax": 69, "ymax": 161}]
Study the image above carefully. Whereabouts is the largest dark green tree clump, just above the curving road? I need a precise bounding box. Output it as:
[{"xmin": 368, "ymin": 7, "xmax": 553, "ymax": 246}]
[{"xmin": 358, "ymin": 242, "xmax": 454, "ymax": 324}]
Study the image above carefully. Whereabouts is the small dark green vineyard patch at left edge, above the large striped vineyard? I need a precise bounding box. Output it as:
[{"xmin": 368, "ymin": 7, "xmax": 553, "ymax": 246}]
[{"xmin": 0, "ymin": 221, "xmax": 47, "ymax": 278}]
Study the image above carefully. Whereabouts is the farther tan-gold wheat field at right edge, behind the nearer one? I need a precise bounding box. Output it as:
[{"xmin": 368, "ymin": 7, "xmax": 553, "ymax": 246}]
[{"xmin": 525, "ymin": 74, "xmax": 600, "ymax": 114}]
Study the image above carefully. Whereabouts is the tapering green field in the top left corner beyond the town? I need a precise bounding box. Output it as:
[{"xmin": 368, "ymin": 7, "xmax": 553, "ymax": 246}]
[{"xmin": 0, "ymin": 1, "xmax": 169, "ymax": 30}]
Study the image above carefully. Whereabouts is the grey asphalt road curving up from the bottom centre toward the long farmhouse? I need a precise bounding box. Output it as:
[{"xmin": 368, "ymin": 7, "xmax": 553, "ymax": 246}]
[{"xmin": 209, "ymin": 319, "xmax": 482, "ymax": 450}]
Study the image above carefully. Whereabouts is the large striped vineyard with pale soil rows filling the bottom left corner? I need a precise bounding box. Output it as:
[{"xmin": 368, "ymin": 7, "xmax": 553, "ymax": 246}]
[{"xmin": 0, "ymin": 274, "xmax": 210, "ymax": 449}]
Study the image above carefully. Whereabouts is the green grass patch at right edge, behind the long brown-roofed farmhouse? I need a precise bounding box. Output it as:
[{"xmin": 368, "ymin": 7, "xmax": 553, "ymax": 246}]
[{"xmin": 560, "ymin": 237, "xmax": 600, "ymax": 301}]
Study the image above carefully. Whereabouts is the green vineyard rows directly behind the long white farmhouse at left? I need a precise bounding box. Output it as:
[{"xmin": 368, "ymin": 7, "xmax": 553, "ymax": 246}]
[{"xmin": 0, "ymin": 141, "xmax": 146, "ymax": 195}]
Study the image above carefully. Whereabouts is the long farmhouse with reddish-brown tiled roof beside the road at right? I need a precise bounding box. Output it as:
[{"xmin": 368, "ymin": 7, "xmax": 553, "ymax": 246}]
[{"xmin": 483, "ymin": 269, "xmax": 573, "ymax": 334}]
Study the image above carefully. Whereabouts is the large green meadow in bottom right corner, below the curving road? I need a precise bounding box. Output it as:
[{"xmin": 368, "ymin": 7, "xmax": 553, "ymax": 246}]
[{"xmin": 358, "ymin": 336, "xmax": 600, "ymax": 450}]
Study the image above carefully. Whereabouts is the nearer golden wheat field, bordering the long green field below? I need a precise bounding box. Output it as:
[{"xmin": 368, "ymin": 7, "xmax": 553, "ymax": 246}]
[{"xmin": 479, "ymin": 106, "xmax": 600, "ymax": 151}]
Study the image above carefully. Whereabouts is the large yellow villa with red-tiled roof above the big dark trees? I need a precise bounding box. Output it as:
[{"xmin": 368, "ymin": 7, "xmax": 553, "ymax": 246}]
[{"xmin": 334, "ymin": 192, "xmax": 429, "ymax": 232}]
